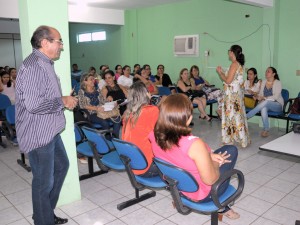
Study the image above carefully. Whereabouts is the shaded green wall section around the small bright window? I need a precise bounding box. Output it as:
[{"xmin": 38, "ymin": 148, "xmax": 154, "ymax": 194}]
[{"xmin": 69, "ymin": 23, "xmax": 122, "ymax": 71}]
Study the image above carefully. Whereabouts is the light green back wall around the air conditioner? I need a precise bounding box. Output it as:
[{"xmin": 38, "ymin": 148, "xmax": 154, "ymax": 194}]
[{"xmin": 123, "ymin": 0, "xmax": 266, "ymax": 85}]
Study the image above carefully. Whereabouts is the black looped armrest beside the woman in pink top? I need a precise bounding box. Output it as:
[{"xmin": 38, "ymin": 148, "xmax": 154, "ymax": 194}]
[{"xmin": 211, "ymin": 169, "xmax": 245, "ymax": 209}]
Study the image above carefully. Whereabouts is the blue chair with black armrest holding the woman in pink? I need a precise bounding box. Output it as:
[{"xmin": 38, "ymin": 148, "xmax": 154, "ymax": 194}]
[{"xmin": 154, "ymin": 158, "xmax": 245, "ymax": 225}]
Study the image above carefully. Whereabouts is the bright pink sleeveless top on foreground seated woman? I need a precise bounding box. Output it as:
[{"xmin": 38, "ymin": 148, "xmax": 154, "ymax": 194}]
[{"xmin": 149, "ymin": 131, "xmax": 211, "ymax": 201}]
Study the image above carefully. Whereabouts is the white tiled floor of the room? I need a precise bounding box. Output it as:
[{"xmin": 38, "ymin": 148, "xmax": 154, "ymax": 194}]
[{"xmin": 0, "ymin": 118, "xmax": 300, "ymax": 225}]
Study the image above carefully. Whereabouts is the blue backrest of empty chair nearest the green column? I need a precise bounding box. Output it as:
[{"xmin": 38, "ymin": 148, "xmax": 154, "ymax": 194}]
[{"xmin": 81, "ymin": 126, "xmax": 114, "ymax": 154}]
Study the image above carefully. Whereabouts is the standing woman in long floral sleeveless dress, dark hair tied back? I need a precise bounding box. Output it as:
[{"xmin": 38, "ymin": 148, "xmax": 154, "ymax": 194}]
[{"xmin": 217, "ymin": 45, "xmax": 250, "ymax": 148}]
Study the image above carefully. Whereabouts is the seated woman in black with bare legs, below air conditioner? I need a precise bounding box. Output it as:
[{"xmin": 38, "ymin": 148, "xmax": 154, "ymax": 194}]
[{"xmin": 177, "ymin": 68, "xmax": 212, "ymax": 122}]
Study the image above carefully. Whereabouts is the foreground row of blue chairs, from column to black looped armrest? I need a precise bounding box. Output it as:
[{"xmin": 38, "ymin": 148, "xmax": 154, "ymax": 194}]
[{"xmin": 75, "ymin": 124, "xmax": 245, "ymax": 225}]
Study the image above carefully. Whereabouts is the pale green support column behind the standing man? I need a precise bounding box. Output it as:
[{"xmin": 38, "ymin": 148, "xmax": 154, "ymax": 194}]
[{"xmin": 19, "ymin": 0, "xmax": 81, "ymax": 205}]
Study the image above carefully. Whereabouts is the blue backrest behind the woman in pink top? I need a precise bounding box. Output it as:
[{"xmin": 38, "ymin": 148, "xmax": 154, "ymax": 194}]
[{"xmin": 154, "ymin": 157, "xmax": 199, "ymax": 192}]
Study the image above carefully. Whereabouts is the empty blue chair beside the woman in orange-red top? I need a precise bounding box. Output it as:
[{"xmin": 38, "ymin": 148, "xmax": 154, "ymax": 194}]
[{"xmin": 77, "ymin": 126, "xmax": 125, "ymax": 175}]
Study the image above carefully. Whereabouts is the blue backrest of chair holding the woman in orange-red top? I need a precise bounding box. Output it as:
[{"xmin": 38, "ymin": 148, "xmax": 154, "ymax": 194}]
[{"xmin": 112, "ymin": 138, "xmax": 148, "ymax": 170}]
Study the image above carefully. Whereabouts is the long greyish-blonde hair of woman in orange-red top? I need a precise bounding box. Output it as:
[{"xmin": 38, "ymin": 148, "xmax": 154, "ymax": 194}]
[{"xmin": 123, "ymin": 81, "xmax": 150, "ymax": 127}]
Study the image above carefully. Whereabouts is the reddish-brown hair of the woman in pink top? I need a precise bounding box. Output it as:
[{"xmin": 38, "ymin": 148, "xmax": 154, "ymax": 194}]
[{"xmin": 154, "ymin": 94, "xmax": 193, "ymax": 151}]
